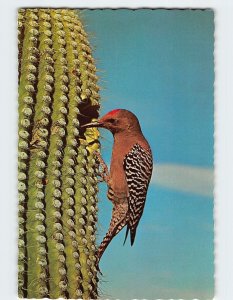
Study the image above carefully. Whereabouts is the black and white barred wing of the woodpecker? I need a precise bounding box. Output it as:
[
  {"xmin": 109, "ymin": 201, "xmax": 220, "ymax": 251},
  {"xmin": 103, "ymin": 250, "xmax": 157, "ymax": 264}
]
[{"xmin": 123, "ymin": 144, "xmax": 153, "ymax": 246}]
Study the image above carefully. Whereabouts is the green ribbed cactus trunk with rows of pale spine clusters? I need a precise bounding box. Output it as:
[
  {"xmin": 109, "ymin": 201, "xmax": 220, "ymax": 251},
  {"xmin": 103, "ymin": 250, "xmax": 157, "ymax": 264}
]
[{"xmin": 18, "ymin": 9, "xmax": 99, "ymax": 299}]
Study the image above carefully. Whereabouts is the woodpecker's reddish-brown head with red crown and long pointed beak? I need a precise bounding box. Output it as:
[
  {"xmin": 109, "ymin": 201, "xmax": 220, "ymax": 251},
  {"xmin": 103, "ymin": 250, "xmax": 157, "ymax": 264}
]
[{"xmin": 82, "ymin": 109, "xmax": 141, "ymax": 134}]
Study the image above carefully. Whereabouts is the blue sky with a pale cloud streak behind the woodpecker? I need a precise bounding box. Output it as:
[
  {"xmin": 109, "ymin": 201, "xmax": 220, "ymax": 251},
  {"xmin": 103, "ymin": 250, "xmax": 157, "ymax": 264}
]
[{"xmin": 82, "ymin": 10, "xmax": 214, "ymax": 299}]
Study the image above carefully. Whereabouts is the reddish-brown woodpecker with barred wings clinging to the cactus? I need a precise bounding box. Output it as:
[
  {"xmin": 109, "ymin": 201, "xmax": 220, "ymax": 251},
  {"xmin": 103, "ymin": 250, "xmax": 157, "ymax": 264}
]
[{"xmin": 83, "ymin": 109, "xmax": 153, "ymax": 261}]
